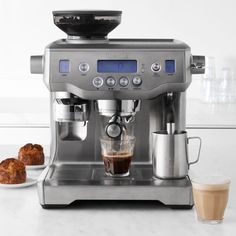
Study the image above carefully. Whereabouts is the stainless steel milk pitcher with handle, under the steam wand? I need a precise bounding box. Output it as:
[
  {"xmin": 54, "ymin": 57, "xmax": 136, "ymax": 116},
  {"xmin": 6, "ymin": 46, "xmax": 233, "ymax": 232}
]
[{"xmin": 152, "ymin": 131, "xmax": 202, "ymax": 179}]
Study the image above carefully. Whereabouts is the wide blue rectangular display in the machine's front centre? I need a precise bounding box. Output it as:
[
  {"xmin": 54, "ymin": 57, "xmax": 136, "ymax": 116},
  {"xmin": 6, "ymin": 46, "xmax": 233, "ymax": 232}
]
[{"xmin": 97, "ymin": 60, "xmax": 137, "ymax": 73}]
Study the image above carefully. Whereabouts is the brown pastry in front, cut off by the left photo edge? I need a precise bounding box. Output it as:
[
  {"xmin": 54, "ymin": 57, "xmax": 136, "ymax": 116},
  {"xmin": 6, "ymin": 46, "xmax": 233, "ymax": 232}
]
[{"xmin": 0, "ymin": 158, "xmax": 26, "ymax": 184}]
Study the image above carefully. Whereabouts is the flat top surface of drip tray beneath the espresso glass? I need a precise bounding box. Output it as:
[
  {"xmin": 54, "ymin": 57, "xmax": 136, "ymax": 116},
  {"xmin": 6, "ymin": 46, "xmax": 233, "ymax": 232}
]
[{"xmin": 47, "ymin": 164, "xmax": 189, "ymax": 186}]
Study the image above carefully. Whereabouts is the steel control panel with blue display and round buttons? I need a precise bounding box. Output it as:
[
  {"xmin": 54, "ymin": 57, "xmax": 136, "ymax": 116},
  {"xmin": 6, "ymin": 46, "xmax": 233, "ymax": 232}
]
[{"xmin": 50, "ymin": 50, "xmax": 187, "ymax": 91}]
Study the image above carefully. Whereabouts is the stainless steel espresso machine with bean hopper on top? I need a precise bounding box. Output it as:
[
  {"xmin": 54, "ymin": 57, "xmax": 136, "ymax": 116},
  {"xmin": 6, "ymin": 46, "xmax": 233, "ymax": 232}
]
[{"xmin": 31, "ymin": 11, "xmax": 205, "ymax": 208}]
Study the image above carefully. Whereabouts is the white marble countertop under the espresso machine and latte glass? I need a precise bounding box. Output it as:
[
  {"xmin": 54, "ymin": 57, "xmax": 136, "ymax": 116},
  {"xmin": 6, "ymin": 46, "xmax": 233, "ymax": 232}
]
[{"xmin": 0, "ymin": 129, "xmax": 236, "ymax": 236}]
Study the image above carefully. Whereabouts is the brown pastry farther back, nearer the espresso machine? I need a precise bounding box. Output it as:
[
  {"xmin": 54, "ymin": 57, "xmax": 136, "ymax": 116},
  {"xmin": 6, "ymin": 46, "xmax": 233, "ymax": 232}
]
[{"xmin": 18, "ymin": 143, "xmax": 44, "ymax": 165}]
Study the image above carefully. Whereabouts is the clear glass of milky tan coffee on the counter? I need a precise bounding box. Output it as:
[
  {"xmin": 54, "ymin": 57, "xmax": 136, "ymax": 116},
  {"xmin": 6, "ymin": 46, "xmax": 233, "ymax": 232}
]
[{"xmin": 192, "ymin": 176, "xmax": 230, "ymax": 224}]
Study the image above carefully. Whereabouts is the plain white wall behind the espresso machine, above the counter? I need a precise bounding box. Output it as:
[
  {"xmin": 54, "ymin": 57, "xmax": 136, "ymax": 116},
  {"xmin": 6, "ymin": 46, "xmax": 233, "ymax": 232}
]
[{"xmin": 0, "ymin": 0, "xmax": 236, "ymax": 125}]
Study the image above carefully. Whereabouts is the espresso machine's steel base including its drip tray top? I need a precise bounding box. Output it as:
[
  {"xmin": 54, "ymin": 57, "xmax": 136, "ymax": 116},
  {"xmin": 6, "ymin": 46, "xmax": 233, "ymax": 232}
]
[{"xmin": 38, "ymin": 163, "xmax": 193, "ymax": 209}]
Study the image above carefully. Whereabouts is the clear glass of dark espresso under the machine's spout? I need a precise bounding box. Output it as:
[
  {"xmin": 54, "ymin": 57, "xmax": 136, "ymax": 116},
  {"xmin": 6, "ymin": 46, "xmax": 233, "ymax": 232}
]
[{"xmin": 100, "ymin": 136, "xmax": 135, "ymax": 177}]
